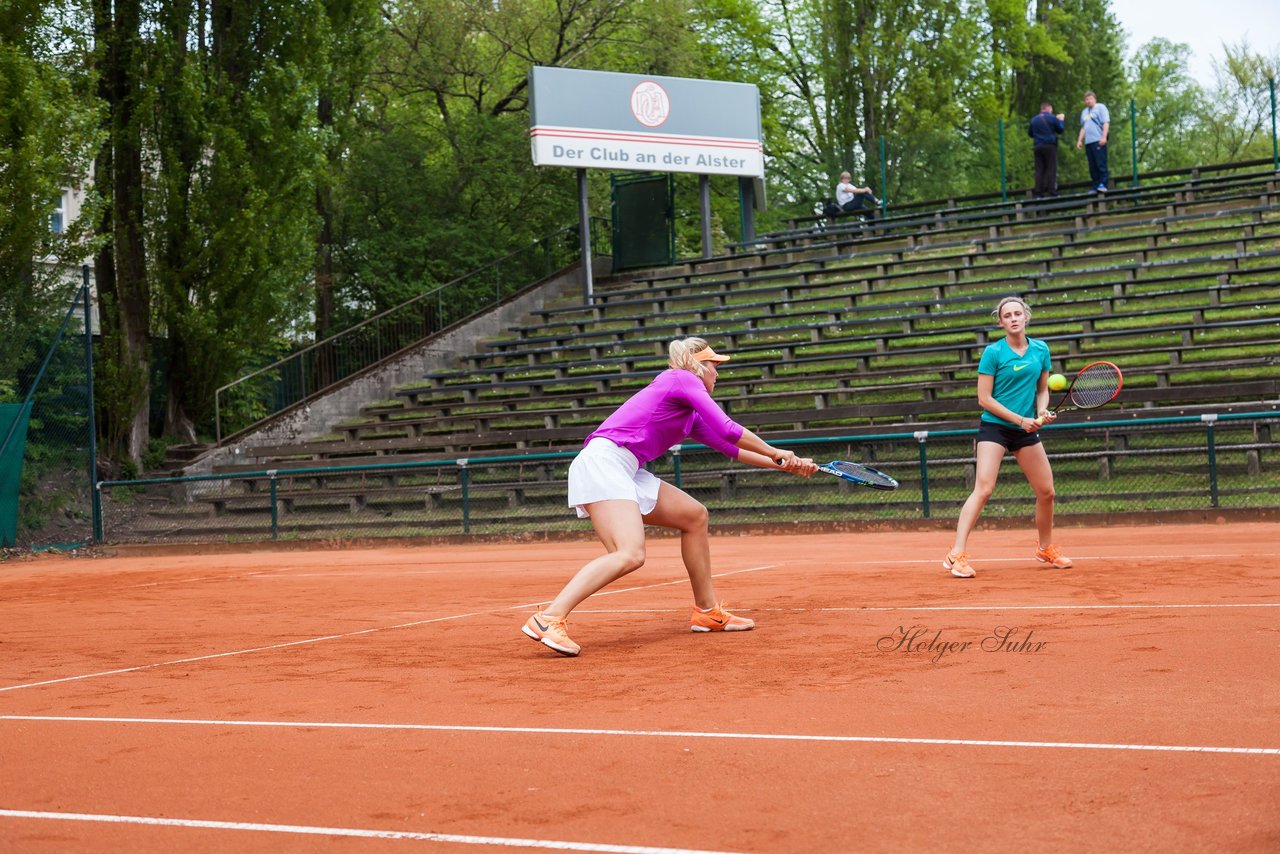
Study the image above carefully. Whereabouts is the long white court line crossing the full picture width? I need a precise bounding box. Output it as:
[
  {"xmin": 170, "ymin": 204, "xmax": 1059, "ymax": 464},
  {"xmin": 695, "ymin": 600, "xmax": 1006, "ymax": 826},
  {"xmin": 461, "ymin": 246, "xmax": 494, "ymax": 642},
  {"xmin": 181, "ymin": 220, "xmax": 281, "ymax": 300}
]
[{"xmin": 0, "ymin": 714, "xmax": 1280, "ymax": 755}]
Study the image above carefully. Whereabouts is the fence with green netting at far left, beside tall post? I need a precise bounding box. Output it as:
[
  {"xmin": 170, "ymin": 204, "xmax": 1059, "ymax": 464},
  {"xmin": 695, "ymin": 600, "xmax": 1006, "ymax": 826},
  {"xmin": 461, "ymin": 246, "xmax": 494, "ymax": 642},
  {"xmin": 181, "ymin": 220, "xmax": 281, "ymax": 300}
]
[{"xmin": 0, "ymin": 277, "xmax": 93, "ymax": 551}]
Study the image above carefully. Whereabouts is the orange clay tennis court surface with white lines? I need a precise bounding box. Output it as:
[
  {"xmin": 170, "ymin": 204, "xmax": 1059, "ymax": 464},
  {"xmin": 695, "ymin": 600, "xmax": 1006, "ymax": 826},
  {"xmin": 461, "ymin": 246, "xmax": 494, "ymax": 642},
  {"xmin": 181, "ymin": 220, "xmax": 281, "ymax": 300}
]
[{"xmin": 0, "ymin": 522, "xmax": 1280, "ymax": 851}]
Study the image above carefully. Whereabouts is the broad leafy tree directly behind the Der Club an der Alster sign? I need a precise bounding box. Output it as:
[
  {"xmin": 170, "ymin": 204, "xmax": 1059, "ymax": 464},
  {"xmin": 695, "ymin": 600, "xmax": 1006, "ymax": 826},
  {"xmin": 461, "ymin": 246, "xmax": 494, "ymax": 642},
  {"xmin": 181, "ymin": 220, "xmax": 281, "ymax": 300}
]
[{"xmin": 334, "ymin": 0, "xmax": 698, "ymax": 313}]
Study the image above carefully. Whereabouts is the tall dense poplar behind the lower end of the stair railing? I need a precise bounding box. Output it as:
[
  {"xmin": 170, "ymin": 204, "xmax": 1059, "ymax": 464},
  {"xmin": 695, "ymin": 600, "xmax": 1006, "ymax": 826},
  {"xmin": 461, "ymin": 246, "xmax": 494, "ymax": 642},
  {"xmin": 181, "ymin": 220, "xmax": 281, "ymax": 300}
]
[{"xmin": 146, "ymin": 0, "xmax": 332, "ymax": 440}]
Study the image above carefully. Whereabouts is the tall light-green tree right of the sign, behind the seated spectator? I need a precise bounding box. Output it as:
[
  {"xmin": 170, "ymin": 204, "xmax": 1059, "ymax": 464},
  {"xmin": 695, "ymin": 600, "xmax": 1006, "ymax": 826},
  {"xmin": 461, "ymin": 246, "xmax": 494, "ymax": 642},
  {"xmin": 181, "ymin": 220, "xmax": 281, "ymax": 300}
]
[{"xmin": 769, "ymin": 0, "xmax": 978, "ymax": 204}]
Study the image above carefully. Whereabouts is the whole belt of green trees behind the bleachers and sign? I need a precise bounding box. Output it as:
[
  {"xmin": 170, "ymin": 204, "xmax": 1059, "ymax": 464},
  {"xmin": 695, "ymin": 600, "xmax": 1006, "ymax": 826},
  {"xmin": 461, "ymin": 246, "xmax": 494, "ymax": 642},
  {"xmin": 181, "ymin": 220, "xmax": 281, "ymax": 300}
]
[{"xmin": 10, "ymin": 0, "xmax": 1280, "ymax": 458}]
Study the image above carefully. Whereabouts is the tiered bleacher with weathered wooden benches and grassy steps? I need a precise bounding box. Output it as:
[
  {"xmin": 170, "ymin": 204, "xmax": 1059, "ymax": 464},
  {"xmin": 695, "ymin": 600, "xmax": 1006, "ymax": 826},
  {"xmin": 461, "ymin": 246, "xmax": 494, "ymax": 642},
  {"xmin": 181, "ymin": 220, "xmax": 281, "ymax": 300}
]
[{"xmin": 135, "ymin": 173, "xmax": 1280, "ymax": 537}]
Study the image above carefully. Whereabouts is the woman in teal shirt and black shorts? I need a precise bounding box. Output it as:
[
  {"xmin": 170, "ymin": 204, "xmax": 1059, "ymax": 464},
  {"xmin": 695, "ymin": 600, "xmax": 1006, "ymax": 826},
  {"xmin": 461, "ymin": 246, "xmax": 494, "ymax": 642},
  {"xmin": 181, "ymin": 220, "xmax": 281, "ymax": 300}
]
[{"xmin": 942, "ymin": 297, "xmax": 1071, "ymax": 579}]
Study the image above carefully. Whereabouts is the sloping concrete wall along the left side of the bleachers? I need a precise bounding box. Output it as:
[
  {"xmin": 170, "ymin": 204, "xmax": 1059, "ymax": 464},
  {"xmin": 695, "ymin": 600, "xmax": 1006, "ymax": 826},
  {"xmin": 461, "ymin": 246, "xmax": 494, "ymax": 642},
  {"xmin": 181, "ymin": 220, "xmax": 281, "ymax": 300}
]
[{"xmin": 183, "ymin": 256, "xmax": 613, "ymax": 475}]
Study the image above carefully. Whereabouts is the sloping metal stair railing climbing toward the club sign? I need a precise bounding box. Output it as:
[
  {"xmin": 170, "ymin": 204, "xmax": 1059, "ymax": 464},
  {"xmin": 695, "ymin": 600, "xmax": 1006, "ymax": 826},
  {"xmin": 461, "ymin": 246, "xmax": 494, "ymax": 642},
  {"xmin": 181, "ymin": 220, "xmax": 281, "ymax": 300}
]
[{"xmin": 214, "ymin": 219, "xmax": 608, "ymax": 444}]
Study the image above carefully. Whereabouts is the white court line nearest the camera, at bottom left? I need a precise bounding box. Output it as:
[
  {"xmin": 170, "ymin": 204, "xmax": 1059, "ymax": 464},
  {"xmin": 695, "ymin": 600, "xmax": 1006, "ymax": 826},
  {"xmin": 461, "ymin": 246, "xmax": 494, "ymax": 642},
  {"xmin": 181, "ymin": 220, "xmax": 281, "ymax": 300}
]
[{"xmin": 0, "ymin": 809, "xmax": 728, "ymax": 854}]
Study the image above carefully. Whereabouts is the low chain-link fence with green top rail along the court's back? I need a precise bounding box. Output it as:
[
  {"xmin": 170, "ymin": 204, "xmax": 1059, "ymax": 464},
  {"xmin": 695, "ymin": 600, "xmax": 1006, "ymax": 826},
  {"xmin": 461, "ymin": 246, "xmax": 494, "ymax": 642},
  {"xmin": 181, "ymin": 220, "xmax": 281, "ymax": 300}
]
[{"xmin": 92, "ymin": 405, "xmax": 1280, "ymax": 542}]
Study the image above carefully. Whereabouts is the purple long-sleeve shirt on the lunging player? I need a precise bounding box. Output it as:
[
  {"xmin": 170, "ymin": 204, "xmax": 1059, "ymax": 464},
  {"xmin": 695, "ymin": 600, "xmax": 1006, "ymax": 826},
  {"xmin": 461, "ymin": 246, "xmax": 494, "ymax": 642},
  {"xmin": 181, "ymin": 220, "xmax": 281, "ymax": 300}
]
[{"xmin": 584, "ymin": 369, "xmax": 742, "ymax": 465}]
